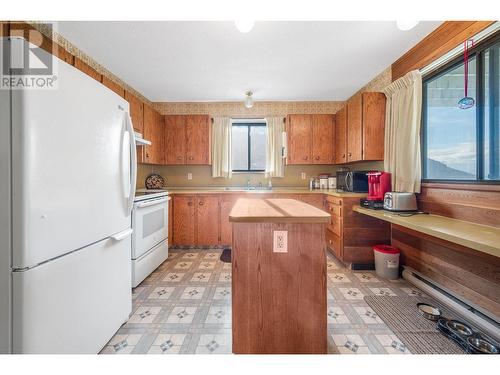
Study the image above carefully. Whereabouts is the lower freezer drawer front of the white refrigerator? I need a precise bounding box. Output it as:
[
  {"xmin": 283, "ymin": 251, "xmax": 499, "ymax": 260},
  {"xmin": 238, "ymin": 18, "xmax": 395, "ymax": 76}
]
[{"xmin": 12, "ymin": 232, "xmax": 132, "ymax": 353}]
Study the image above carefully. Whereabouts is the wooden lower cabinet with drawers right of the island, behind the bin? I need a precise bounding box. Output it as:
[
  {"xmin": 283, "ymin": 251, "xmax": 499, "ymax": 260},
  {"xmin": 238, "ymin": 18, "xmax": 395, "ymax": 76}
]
[{"xmin": 325, "ymin": 195, "xmax": 391, "ymax": 267}]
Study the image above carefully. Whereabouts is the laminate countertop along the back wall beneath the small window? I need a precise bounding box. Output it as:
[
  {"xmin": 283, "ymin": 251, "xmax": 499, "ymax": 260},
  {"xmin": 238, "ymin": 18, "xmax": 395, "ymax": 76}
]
[{"xmin": 166, "ymin": 187, "xmax": 367, "ymax": 198}]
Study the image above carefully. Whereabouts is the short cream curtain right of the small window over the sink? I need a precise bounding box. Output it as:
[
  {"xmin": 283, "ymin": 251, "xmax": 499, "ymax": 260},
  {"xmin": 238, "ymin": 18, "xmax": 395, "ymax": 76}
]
[{"xmin": 266, "ymin": 117, "xmax": 285, "ymax": 177}]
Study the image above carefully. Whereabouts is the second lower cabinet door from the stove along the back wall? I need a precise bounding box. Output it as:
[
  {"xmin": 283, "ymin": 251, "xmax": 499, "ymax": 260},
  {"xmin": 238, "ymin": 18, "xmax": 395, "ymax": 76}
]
[{"xmin": 196, "ymin": 195, "xmax": 219, "ymax": 245}]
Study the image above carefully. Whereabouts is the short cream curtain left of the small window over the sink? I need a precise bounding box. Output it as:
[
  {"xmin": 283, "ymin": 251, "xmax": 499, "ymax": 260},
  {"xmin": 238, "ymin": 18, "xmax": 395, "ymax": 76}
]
[{"xmin": 212, "ymin": 117, "xmax": 233, "ymax": 178}]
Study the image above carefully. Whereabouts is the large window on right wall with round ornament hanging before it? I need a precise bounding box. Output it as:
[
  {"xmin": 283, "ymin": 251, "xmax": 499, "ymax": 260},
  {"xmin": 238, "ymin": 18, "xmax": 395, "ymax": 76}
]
[{"xmin": 422, "ymin": 35, "xmax": 500, "ymax": 182}]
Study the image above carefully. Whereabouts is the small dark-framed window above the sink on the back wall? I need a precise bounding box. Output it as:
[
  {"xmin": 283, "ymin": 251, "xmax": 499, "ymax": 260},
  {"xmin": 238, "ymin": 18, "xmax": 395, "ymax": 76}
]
[{"xmin": 231, "ymin": 122, "xmax": 267, "ymax": 172}]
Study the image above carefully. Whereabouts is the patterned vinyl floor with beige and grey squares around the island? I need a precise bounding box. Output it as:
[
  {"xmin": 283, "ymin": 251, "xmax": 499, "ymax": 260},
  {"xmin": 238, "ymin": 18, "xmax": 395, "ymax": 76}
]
[{"xmin": 101, "ymin": 249, "xmax": 423, "ymax": 354}]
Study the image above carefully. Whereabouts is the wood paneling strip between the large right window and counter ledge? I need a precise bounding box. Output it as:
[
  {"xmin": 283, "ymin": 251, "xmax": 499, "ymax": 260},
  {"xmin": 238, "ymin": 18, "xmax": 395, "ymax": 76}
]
[{"xmin": 417, "ymin": 183, "xmax": 500, "ymax": 227}]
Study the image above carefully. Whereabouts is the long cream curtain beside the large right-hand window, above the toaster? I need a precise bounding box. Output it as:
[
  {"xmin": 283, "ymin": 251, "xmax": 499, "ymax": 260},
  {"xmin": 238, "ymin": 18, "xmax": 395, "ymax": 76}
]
[{"xmin": 384, "ymin": 70, "xmax": 422, "ymax": 193}]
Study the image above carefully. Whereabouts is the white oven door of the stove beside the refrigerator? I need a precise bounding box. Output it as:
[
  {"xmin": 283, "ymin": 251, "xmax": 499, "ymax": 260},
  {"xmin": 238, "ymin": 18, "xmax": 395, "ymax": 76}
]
[{"xmin": 132, "ymin": 197, "xmax": 170, "ymax": 259}]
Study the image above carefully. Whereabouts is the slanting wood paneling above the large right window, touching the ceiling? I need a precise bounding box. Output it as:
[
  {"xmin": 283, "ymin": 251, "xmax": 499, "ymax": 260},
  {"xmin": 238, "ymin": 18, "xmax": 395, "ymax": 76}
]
[{"xmin": 392, "ymin": 21, "xmax": 494, "ymax": 81}]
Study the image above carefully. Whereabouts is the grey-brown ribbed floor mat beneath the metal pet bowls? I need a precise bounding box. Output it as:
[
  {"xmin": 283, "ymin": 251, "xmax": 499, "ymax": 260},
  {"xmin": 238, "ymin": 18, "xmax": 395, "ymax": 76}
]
[{"xmin": 364, "ymin": 296, "xmax": 465, "ymax": 354}]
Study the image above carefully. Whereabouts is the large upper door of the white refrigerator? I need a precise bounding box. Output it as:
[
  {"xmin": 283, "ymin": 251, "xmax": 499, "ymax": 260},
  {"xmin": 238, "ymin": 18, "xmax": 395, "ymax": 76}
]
[{"xmin": 11, "ymin": 38, "xmax": 135, "ymax": 268}]
